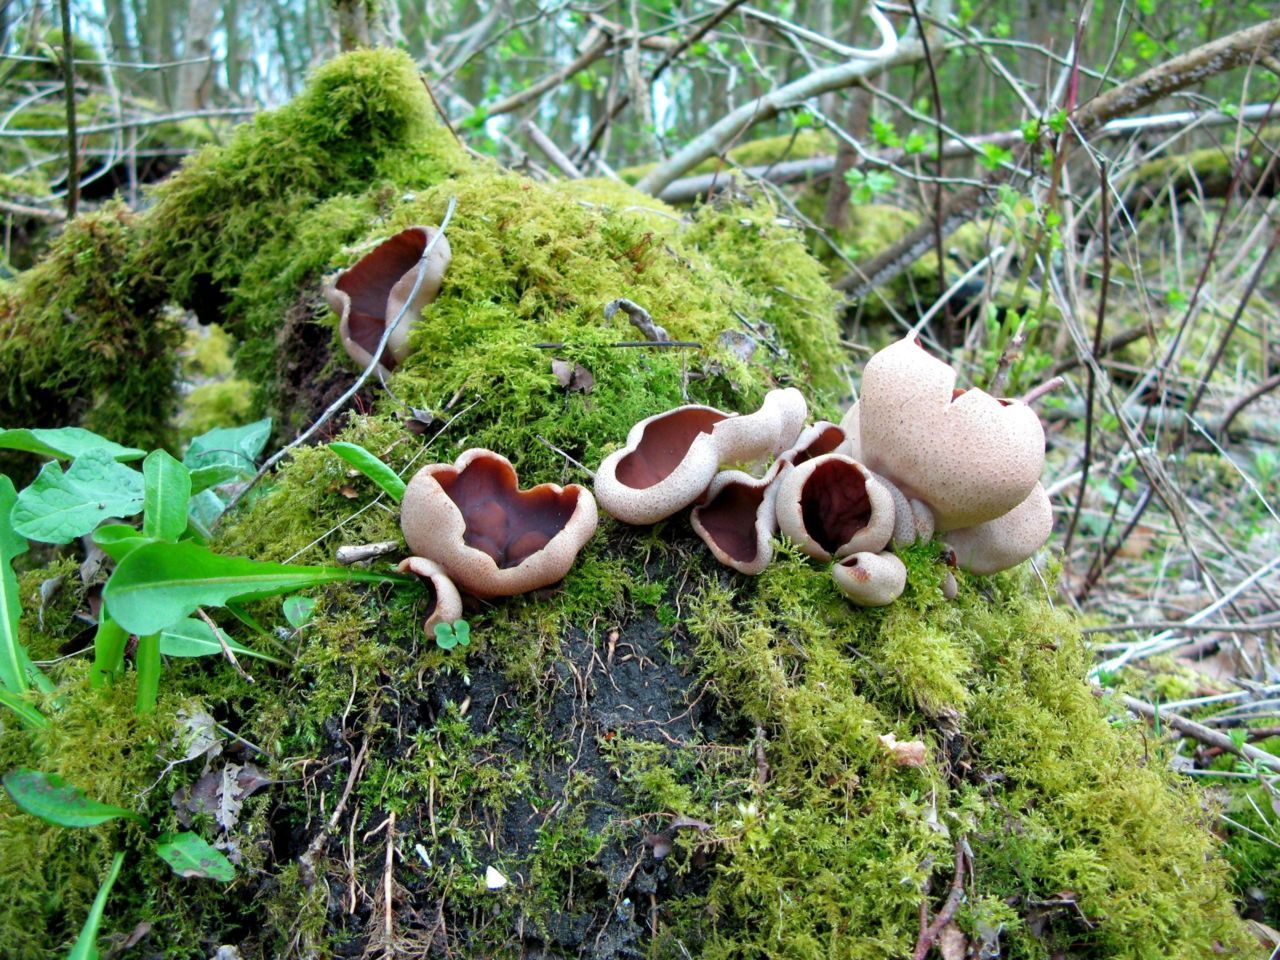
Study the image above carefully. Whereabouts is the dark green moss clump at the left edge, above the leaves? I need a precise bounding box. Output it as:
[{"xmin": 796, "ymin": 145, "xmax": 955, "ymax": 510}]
[{"xmin": 0, "ymin": 204, "xmax": 182, "ymax": 463}]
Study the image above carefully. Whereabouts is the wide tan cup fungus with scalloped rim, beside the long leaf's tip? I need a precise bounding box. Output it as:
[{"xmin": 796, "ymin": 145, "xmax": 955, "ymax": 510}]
[{"xmin": 401, "ymin": 449, "xmax": 598, "ymax": 599}]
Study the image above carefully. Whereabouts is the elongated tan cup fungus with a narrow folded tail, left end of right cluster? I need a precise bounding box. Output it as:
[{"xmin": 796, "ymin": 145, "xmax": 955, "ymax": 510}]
[{"xmin": 595, "ymin": 388, "xmax": 806, "ymax": 524}]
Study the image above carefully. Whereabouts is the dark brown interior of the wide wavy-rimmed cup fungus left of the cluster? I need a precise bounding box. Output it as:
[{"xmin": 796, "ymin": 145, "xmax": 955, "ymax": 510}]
[{"xmin": 435, "ymin": 457, "xmax": 579, "ymax": 570}]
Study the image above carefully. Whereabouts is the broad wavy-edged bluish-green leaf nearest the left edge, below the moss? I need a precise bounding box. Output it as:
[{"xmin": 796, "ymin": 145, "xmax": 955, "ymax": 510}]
[{"xmin": 12, "ymin": 449, "xmax": 143, "ymax": 543}]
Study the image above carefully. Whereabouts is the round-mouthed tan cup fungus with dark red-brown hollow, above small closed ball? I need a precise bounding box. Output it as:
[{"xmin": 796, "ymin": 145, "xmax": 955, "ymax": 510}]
[{"xmin": 777, "ymin": 453, "xmax": 893, "ymax": 561}]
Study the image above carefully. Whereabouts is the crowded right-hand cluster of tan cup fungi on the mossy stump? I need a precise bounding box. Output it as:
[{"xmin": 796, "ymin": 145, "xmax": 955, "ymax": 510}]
[{"xmin": 595, "ymin": 337, "xmax": 1053, "ymax": 607}]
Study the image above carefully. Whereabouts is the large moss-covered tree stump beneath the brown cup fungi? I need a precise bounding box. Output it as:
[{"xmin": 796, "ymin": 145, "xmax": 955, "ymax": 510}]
[{"xmin": 0, "ymin": 52, "xmax": 1248, "ymax": 959}]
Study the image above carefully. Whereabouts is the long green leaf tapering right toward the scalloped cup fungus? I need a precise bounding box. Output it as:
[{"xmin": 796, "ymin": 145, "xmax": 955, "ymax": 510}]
[{"xmin": 102, "ymin": 541, "xmax": 412, "ymax": 636}]
